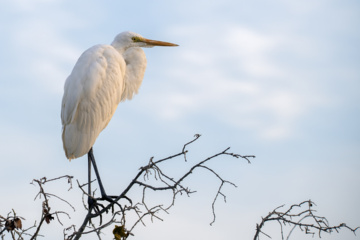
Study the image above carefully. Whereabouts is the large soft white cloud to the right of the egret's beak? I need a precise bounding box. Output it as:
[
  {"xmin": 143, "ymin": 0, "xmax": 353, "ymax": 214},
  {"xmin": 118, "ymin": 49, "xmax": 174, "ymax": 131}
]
[{"xmin": 145, "ymin": 25, "xmax": 327, "ymax": 140}]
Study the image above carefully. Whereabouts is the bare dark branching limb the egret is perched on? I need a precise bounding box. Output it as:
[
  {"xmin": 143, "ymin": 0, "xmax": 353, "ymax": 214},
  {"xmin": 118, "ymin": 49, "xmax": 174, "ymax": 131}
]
[{"xmin": 67, "ymin": 134, "xmax": 255, "ymax": 240}]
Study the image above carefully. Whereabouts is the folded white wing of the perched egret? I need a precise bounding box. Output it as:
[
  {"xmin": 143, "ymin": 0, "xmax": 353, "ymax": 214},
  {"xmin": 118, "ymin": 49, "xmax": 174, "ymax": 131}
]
[{"xmin": 61, "ymin": 45, "xmax": 126, "ymax": 159}]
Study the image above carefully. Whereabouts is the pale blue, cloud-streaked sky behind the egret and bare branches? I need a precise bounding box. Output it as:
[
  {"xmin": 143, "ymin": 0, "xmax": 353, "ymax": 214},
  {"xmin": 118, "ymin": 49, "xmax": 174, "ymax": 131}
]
[{"xmin": 0, "ymin": 0, "xmax": 360, "ymax": 239}]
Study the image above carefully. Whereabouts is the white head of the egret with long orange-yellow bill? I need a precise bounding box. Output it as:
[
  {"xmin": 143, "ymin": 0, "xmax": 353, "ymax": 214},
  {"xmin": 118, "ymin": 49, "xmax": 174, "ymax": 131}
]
[{"xmin": 111, "ymin": 32, "xmax": 178, "ymax": 49}]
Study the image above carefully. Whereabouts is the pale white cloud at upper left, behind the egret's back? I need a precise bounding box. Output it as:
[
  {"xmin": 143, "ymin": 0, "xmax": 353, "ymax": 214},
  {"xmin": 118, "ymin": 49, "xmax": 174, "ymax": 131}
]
[{"xmin": 8, "ymin": 6, "xmax": 81, "ymax": 94}]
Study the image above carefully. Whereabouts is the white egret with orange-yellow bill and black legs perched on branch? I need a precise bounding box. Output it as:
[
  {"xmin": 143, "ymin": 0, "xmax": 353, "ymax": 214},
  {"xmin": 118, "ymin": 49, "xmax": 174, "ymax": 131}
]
[{"xmin": 61, "ymin": 32, "xmax": 178, "ymax": 204}]
